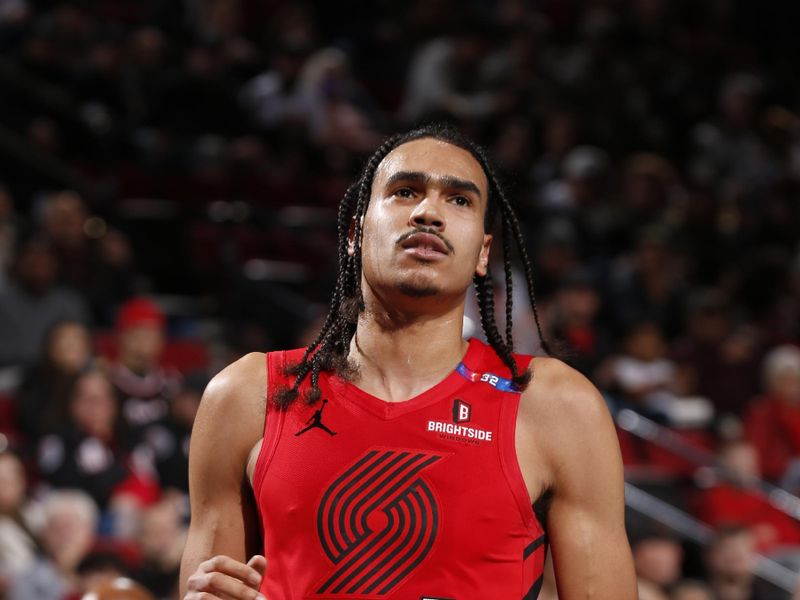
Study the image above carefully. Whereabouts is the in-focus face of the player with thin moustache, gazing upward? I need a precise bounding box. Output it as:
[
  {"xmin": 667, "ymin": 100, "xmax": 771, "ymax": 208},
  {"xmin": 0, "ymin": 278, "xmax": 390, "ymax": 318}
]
[{"xmin": 361, "ymin": 138, "xmax": 491, "ymax": 298}]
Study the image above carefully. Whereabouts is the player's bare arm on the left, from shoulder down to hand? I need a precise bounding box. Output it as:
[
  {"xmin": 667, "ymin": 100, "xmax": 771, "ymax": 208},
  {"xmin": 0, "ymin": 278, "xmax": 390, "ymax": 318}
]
[{"xmin": 180, "ymin": 353, "xmax": 266, "ymax": 594}]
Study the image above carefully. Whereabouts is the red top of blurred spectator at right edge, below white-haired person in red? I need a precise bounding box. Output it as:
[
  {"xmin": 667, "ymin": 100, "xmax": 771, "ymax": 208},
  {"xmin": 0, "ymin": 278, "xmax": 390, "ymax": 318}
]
[{"xmin": 696, "ymin": 484, "xmax": 800, "ymax": 552}]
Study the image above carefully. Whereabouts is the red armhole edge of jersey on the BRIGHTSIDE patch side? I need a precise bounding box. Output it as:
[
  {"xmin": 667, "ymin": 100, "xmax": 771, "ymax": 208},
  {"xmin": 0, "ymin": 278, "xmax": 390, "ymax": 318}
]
[{"xmin": 498, "ymin": 356, "xmax": 544, "ymax": 537}]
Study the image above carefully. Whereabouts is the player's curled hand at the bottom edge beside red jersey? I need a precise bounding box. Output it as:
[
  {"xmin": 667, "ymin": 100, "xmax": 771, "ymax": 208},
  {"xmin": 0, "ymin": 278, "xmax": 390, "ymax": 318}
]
[{"xmin": 183, "ymin": 554, "xmax": 267, "ymax": 600}]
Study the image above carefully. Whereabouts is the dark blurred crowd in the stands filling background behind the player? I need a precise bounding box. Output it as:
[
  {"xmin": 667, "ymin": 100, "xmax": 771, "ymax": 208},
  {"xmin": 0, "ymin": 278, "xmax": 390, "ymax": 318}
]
[{"xmin": 0, "ymin": 0, "xmax": 800, "ymax": 600}]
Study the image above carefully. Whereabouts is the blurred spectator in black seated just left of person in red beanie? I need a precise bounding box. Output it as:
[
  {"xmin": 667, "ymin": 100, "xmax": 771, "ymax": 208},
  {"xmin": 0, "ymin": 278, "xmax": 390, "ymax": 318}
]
[{"xmin": 17, "ymin": 321, "xmax": 92, "ymax": 443}]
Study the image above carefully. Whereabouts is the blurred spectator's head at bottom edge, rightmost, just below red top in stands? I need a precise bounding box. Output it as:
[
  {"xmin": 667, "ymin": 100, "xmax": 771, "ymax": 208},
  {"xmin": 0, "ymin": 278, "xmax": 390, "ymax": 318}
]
[{"xmin": 706, "ymin": 527, "xmax": 766, "ymax": 600}]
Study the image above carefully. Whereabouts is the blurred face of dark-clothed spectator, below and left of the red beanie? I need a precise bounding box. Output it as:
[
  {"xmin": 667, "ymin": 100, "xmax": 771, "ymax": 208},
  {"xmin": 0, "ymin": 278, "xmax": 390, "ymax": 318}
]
[{"xmin": 70, "ymin": 372, "xmax": 117, "ymax": 441}]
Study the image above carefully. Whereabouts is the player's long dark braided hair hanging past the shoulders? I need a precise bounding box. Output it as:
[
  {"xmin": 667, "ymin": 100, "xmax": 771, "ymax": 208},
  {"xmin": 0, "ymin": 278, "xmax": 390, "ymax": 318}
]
[{"xmin": 272, "ymin": 123, "xmax": 550, "ymax": 408}]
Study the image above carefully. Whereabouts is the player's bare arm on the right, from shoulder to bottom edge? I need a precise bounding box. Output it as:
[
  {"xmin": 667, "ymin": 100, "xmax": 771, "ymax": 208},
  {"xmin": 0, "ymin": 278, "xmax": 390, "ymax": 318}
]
[{"xmin": 525, "ymin": 360, "xmax": 636, "ymax": 600}]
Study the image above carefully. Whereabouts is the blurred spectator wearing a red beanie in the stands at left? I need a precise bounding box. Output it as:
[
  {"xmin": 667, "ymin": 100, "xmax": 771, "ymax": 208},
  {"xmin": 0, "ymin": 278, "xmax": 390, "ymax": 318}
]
[{"xmin": 111, "ymin": 298, "xmax": 180, "ymax": 437}]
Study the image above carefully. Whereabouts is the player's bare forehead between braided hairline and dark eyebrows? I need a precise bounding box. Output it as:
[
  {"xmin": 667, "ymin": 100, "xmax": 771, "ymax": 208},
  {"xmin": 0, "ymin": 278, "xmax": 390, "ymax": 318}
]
[{"xmin": 373, "ymin": 138, "xmax": 489, "ymax": 199}]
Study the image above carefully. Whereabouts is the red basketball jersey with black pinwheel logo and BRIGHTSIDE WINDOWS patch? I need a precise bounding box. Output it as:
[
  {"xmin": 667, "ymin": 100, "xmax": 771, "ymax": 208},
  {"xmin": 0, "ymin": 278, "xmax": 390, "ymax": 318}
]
[{"xmin": 253, "ymin": 339, "xmax": 546, "ymax": 600}]
